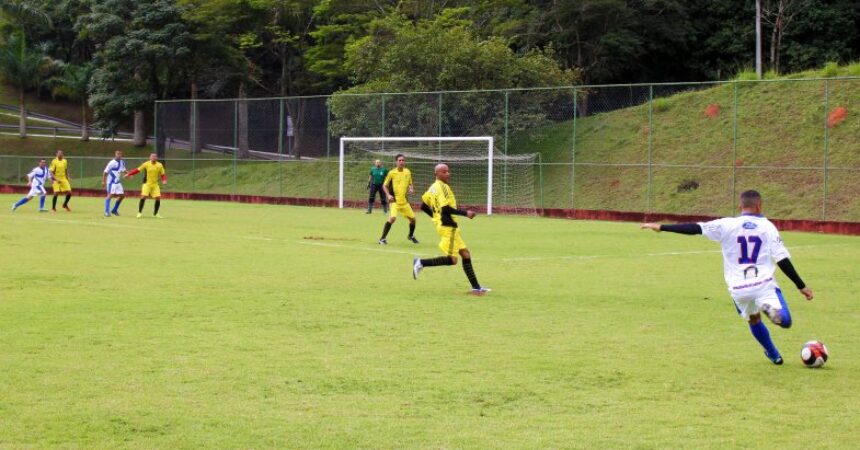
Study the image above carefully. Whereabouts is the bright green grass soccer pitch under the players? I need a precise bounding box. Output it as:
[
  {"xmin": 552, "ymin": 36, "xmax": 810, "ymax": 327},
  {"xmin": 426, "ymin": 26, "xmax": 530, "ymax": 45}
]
[{"xmin": 0, "ymin": 195, "xmax": 860, "ymax": 449}]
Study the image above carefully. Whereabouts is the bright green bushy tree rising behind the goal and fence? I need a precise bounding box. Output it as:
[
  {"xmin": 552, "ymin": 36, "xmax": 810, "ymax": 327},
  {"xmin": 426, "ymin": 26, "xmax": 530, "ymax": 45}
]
[{"xmin": 330, "ymin": 8, "xmax": 578, "ymax": 136}]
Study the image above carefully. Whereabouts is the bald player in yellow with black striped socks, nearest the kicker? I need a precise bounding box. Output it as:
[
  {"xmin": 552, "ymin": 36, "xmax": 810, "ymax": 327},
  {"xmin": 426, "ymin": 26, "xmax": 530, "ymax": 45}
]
[{"xmin": 412, "ymin": 164, "xmax": 490, "ymax": 295}]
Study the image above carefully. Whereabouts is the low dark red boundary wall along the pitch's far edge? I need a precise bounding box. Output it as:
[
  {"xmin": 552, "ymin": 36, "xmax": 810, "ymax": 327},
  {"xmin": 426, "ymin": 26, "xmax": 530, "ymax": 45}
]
[{"xmin": 0, "ymin": 185, "xmax": 860, "ymax": 235}]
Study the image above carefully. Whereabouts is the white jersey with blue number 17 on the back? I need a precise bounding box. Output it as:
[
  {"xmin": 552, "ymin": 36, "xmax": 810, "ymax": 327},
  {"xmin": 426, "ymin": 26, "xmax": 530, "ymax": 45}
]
[{"xmin": 699, "ymin": 214, "xmax": 790, "ymax": 293}]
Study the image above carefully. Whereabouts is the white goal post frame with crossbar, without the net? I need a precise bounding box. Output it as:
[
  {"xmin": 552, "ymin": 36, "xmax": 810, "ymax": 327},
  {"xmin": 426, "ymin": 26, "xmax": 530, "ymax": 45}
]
[{"xmin": 338, "ymin": 136, "xmax": 494, "ymax": 214}]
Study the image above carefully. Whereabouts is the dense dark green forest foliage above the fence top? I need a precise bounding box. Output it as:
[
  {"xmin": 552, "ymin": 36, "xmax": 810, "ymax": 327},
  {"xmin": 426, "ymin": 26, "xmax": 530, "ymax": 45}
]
[{"xmin": 0, "ymin": 0, "xmax": 860, "ymax": 141}]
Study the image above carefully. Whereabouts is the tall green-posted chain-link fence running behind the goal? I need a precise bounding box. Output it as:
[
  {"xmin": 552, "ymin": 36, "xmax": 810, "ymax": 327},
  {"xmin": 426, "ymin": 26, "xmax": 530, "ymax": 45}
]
[{"xmin": 0, "ymin": 78, "xmax": 860, "ymax": 222}]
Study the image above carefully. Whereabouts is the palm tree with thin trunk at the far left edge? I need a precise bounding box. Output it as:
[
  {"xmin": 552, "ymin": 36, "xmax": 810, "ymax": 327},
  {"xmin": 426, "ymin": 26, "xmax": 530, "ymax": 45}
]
[{"xmin": 0, "ymin": 32, "xmax": 47, "ymax": 138}]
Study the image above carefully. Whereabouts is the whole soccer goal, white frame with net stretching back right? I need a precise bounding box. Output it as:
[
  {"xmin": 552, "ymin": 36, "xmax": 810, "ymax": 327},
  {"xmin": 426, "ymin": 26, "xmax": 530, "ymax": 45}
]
[{"xmin": 339, "ymin": 137, "xmax": 537, "ymax": 214}]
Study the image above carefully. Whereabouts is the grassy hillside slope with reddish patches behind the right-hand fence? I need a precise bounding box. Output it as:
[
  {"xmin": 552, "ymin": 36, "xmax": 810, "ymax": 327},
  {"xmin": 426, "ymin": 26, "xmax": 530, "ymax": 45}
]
[{"xmin": 508, "ymin": 65, "xmax": 860, "ymax": 221}]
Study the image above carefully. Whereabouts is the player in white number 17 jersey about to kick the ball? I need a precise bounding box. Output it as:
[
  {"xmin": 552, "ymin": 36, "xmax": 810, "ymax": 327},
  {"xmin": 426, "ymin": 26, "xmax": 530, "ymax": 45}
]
[{"xmin": 641, "ymin": 190, "xmax": 812, "ymax": 364}]
